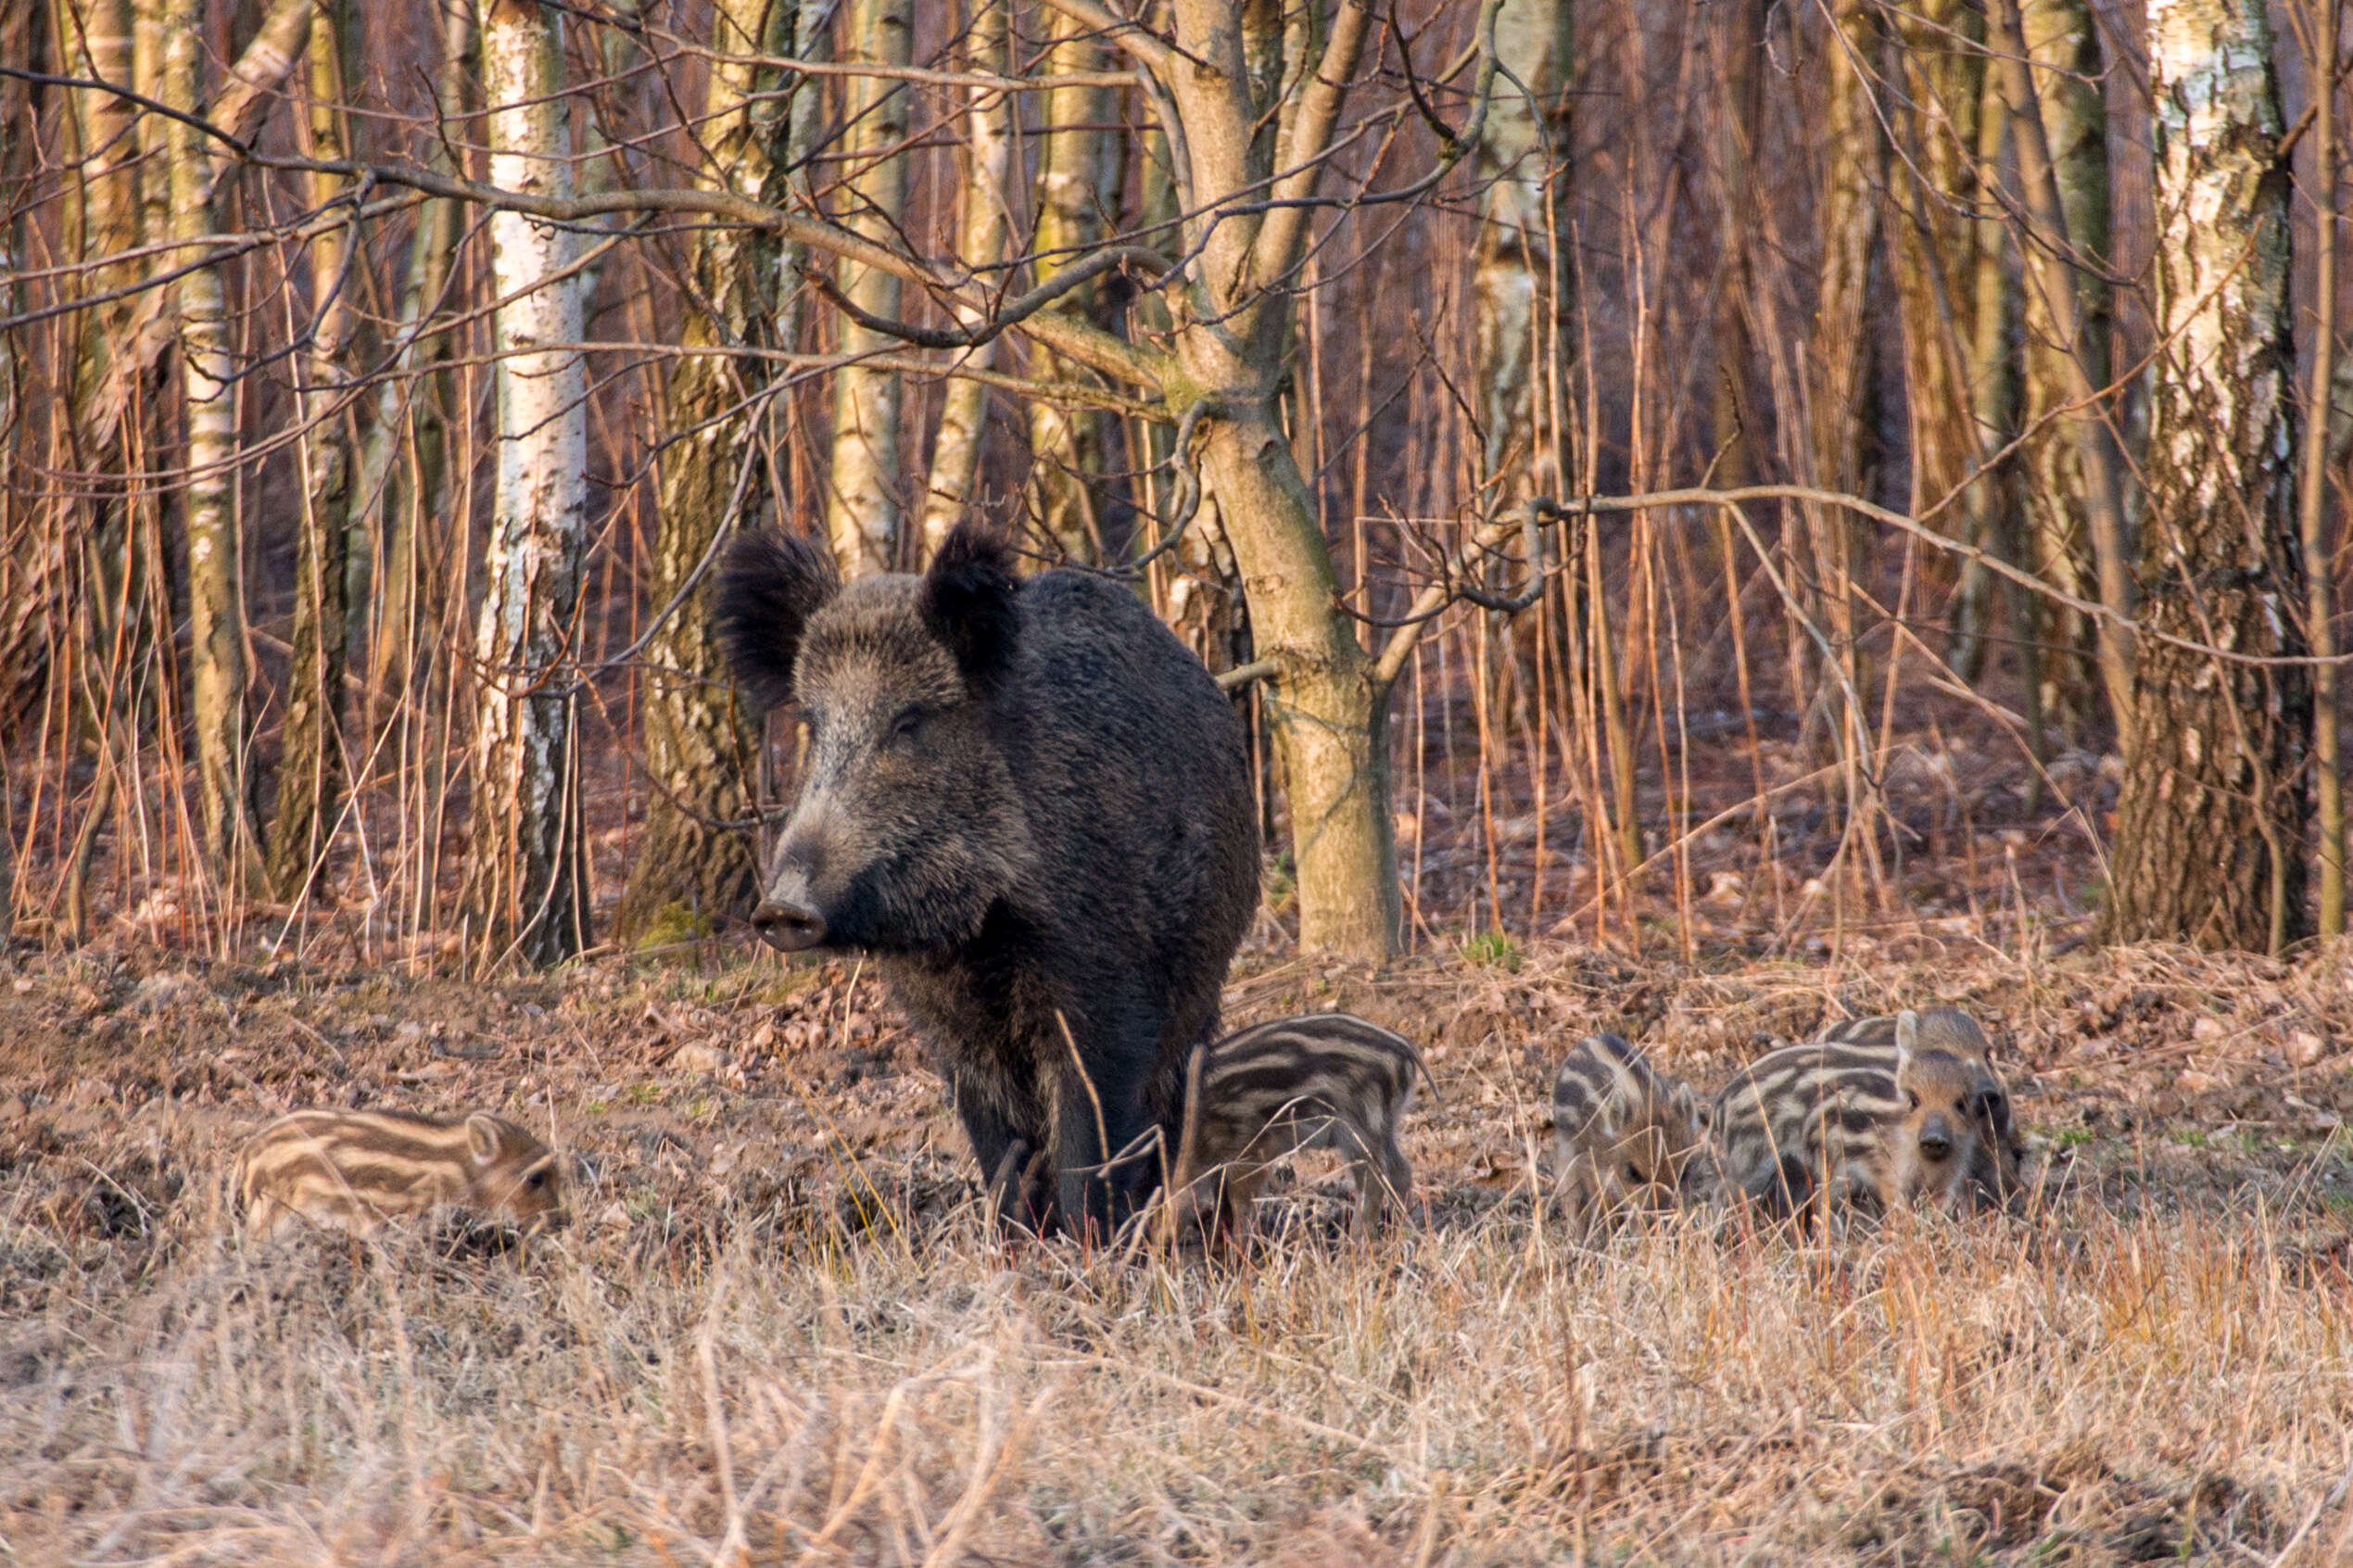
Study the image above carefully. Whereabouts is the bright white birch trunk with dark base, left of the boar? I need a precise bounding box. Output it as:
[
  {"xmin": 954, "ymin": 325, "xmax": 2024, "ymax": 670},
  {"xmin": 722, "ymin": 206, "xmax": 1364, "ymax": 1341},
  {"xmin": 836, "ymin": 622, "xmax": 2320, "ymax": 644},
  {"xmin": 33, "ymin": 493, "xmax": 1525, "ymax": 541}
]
[{"xmin": 466, "ymin": 0, "xmax": 588, "ymax": 963}]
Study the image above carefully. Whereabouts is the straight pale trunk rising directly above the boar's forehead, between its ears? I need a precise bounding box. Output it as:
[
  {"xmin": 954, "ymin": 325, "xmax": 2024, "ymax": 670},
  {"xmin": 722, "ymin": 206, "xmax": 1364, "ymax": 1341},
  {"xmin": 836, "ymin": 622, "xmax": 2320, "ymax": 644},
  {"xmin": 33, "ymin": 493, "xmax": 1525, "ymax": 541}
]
[{"xmin": 826, "ymin": 0, "xmax": 916, "ymax": 576}]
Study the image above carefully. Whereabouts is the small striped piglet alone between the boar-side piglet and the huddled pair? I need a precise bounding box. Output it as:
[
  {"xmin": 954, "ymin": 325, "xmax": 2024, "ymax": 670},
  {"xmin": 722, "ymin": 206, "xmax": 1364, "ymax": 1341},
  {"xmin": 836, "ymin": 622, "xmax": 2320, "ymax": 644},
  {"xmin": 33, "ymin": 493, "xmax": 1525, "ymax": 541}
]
[{"xmin": 1553, "ymin": 1033, "xmax": 1701, "ymax": 1227}]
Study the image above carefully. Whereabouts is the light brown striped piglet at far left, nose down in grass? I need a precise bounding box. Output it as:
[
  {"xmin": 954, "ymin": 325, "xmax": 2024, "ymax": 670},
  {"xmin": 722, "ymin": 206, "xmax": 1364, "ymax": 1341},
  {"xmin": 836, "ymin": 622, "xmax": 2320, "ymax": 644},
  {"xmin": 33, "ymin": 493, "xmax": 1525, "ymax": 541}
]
[{"xmin": 235, "ymin": 1096, "xmax": 563, "ymax": 1236}]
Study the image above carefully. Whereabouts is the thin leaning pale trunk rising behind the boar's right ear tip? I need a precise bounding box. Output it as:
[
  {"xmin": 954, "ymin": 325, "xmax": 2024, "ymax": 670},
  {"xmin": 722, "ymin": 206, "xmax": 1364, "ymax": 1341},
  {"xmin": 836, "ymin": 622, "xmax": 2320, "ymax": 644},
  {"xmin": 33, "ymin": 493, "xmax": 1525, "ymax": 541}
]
[{"xmin": 922, "ymin": 0, "xmax": 1014, "ymax": 563}]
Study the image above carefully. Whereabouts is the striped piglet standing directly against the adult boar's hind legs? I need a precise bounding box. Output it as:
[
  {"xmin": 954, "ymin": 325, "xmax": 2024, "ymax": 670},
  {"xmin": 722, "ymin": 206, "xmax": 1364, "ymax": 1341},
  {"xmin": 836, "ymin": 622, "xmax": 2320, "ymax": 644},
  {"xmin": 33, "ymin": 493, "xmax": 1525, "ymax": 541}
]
[{"xmin": 1171, "ymin": 1012, "xmax": 1428, "ymax": 1236}]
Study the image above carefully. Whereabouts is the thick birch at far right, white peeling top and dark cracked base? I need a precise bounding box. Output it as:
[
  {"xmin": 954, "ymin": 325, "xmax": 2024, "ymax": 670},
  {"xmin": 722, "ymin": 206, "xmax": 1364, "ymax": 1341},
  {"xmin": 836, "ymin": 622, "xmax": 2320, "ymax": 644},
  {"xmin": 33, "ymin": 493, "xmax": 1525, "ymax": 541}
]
[{"xmin": 2108, "ymin": 0, "xmax": 2313, "ymax": 951}]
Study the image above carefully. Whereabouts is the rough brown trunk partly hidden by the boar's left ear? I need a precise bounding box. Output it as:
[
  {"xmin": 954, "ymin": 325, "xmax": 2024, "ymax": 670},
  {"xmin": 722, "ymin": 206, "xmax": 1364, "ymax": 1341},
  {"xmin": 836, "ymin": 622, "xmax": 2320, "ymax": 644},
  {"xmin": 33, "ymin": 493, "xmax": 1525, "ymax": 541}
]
[{"xmin": 614, "ymin": 0, "xmax": 809, "ymax": 942}]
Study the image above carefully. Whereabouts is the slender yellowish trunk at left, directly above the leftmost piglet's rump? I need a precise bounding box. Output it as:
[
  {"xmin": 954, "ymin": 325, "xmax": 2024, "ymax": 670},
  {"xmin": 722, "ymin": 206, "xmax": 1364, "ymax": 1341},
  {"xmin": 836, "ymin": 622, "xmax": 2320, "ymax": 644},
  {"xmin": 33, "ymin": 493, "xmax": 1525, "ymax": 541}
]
[{"xmin": 165, "ymin": 0, "xmax": 261, "ymax": 897}]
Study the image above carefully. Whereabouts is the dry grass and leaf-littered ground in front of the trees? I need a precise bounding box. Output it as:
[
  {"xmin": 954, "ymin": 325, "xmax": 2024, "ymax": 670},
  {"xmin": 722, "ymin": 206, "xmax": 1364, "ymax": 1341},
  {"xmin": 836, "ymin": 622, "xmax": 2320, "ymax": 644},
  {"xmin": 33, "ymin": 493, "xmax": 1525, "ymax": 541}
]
[{"xmin": 0, "ymin": 942, "xmax": 2353, "ymax": 1568}]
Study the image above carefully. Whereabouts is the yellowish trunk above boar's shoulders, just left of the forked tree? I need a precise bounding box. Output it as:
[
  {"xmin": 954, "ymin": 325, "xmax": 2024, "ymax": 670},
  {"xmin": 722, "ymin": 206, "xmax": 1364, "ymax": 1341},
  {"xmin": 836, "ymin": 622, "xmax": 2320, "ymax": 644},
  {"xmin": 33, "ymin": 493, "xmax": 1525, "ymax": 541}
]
[{"xmin": 1029, "ymin": 0, "xmax": 1120, "ymax": 563}]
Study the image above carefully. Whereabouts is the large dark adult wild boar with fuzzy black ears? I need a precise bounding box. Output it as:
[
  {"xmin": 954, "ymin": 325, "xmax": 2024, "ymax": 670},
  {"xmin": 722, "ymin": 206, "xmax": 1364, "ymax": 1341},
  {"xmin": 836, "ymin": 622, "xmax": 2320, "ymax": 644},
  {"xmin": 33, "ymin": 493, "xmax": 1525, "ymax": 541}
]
[{"xmin": 717, "ymin": 525, "xmax": 1259, "ymax": 1233}]
